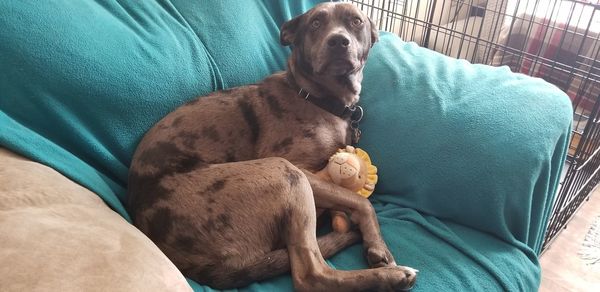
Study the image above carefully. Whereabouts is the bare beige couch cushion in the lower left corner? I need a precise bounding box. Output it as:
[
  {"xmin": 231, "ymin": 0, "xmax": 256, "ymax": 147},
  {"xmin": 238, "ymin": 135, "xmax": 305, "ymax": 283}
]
[{"xmin": 0, "ymin": 148, "xmax": 191, "ymax": 291}]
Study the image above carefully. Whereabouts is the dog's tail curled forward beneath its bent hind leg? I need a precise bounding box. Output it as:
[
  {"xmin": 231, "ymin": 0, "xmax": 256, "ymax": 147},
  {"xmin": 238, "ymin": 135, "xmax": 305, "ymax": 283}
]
[{"xmin": 196, "ymin": 230, "xmax": 361, "ymax": 289}]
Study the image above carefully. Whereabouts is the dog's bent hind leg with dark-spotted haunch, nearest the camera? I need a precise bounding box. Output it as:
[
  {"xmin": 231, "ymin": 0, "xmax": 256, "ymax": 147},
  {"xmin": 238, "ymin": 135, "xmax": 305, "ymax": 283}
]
[{"xmin": 139, "ymin": 158, "xmax": 415, "ymax": 291}]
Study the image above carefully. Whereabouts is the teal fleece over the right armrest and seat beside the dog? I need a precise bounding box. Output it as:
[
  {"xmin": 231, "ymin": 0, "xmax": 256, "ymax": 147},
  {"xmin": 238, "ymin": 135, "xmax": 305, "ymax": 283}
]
[{"xmin": 352, "ymin": 34, "xmax": 572, "ymax": 291}]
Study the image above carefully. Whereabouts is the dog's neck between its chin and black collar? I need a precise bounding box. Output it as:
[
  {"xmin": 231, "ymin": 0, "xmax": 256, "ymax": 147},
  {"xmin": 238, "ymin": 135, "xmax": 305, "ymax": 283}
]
[{"xmin": 287, "ymin": 53, "xmax": 363, "ymax": 106}]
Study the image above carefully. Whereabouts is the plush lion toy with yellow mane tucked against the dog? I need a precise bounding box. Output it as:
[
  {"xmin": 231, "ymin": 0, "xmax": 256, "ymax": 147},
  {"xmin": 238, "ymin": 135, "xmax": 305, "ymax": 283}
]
[{"xmin": 317, "ymin": 146, "xmax": 377, "ymax": 233}]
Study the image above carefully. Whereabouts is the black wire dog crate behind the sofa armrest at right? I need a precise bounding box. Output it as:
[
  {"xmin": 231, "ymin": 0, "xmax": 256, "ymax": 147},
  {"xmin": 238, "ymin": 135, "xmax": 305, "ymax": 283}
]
[{"xmin": 348, "ymin": 0, "xmax": 600, "ymax": 250}]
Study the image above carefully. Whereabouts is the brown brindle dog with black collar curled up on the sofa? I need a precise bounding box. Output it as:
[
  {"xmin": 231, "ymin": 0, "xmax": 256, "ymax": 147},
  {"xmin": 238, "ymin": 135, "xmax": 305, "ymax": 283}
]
[{"xmin": 129, "ymin": 3, "xmax": 416, "ymax": 291}]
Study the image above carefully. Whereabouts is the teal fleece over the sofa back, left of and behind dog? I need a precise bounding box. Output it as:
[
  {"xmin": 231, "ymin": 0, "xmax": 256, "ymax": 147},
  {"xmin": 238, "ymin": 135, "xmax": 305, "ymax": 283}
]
[{"xmin": 0, "ymin": 0, "xmax": 319, "ymax": 219}]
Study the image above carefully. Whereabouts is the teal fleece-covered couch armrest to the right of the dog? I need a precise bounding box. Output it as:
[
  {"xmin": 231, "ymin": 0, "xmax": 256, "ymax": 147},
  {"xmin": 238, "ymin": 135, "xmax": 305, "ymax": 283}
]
[{"xmin": 360, "ymin": 33, "xmax": 572, "ymax": 252}]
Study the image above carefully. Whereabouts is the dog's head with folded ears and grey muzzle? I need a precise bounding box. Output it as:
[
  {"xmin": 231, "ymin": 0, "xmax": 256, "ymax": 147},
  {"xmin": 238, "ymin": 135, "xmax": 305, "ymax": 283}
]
[{"xmin": 280, "ymin": 3, "xmax": 378, "ymax": 76}]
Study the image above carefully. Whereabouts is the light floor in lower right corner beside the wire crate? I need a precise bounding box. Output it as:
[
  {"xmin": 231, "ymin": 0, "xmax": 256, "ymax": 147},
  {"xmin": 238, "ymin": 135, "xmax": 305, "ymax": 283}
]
[{"xmin": 540, "ymin": 188, "xmax": 600, "ymax": 292}]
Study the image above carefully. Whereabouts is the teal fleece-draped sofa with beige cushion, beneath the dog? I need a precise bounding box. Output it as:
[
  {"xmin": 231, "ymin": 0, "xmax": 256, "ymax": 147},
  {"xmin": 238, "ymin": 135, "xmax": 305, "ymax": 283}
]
[{"xmin": 0, "ymin": 0, "xmax": 572, "ymax": 291}]
